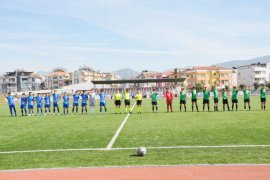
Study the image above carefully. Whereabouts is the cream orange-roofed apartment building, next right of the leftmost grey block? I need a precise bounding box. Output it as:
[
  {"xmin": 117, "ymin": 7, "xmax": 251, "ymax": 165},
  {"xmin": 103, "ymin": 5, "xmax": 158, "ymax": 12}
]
[{"xmin": 45, "ymin": 68, "xmax": 72, "ymax": 89}]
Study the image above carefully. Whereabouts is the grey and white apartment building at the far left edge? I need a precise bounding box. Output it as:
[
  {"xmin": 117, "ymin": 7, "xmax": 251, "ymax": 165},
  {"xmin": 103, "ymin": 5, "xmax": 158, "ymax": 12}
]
[{"xmin": 0, "ymin": 69, "xmax": 42, "ymax": 93}]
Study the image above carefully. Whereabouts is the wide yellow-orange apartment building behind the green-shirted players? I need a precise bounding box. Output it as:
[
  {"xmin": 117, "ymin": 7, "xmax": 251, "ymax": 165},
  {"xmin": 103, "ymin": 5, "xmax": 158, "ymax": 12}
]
[{"xmin": 183, "ymin": 66, "xmax": 233, "ymax": 88}]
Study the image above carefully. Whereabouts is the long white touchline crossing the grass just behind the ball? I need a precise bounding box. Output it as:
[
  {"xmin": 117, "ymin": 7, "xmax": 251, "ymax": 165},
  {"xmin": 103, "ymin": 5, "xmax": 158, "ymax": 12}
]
[{"xmin": 0, "ymin": 145, "xmax": 270, "ymax": 154}]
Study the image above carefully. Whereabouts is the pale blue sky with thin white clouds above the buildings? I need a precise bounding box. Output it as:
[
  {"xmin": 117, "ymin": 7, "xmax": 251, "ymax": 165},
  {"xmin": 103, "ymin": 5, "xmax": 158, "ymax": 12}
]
[{"xmin": 0, "ymin": 0, "xmax": 270, "ymax": 73}]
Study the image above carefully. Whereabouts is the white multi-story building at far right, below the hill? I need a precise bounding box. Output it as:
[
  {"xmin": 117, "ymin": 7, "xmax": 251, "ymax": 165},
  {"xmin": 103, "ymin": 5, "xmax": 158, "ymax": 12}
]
[{"xmin": 237, "ymin": 63, "xmax": 270, "ymax": 87}]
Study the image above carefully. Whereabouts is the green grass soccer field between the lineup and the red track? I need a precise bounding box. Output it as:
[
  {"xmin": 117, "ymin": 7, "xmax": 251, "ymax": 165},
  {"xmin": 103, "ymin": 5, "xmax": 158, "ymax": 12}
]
[{"xmin": 0, "ymin": 97, "xmax": 270, "ymax": 170}]
